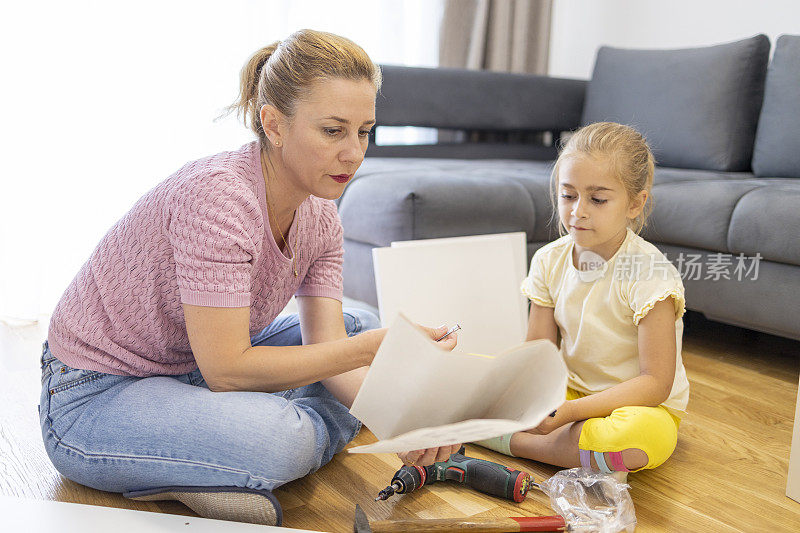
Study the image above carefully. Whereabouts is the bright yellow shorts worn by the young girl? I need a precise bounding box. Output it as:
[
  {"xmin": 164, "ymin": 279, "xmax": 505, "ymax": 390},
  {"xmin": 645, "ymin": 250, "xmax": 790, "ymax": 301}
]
[{"xmin": 567, "ymin": 389, "xmax": 681, "ymax": 472}]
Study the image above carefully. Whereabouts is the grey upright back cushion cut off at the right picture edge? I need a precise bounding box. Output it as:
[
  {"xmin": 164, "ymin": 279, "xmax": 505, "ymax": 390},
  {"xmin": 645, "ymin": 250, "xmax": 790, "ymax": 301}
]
[{"xmin": 753, "ymin": 35, "xmax": 800, "ymax": 178}]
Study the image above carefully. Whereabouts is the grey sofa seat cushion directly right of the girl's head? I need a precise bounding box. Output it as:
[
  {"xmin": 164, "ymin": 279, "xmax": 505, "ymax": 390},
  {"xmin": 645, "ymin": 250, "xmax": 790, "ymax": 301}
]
[{"xmin": 642, "ymin": 179, "xmax": 765, "ymax": 252}]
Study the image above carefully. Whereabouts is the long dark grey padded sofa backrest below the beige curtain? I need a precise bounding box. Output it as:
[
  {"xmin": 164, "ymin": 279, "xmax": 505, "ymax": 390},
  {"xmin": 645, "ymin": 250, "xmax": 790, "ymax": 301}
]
[{"xmin": 376, "ymin": 65, "xmax": 587, "ymax": 133}]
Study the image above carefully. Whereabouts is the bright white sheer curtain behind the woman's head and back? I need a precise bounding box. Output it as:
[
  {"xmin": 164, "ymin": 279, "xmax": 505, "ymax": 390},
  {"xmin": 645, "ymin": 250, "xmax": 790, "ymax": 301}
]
[{"xmin": 0, "ymin": 0, "xmax": 442, "ymax": 327}]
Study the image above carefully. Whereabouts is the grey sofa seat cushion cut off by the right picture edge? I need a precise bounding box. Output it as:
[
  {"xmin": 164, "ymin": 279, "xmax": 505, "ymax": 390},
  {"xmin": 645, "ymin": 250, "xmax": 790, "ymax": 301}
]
[{"xmin": 728, "ymin": 178, "xmax": 800, "ymax": 265}]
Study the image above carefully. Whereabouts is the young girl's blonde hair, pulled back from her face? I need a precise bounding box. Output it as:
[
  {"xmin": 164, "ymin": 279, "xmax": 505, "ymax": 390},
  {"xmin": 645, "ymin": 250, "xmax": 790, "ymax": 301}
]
[{"xmin": 550, "ymin": 122, "xmax": 655, "ymax": 236}]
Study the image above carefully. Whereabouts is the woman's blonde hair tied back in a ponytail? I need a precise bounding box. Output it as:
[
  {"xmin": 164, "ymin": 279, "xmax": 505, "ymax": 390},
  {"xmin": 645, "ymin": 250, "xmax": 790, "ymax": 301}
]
[{"xmin": 228, "ymin": 30, "xmax": 382, "ymax": 147}]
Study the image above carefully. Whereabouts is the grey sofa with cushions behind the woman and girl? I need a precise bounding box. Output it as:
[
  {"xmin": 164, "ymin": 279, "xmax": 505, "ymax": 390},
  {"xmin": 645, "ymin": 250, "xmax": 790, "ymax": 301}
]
[{"xmin": 339, "ymin": 35, "xmax": 800, "ymax": 339}]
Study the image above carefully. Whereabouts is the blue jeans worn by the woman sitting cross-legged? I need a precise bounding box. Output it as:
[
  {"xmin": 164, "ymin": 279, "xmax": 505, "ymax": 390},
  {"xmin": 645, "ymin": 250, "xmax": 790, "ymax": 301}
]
[{"xmin": 39, "ymin": 309, "xmax": 378, "ymax": 492}]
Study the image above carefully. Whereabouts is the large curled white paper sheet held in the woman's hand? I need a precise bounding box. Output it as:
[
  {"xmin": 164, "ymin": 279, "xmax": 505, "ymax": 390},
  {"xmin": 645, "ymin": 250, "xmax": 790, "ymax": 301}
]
[{"xmin": 349, "ymin": 314, "xmax": 567, "ymax": 453}]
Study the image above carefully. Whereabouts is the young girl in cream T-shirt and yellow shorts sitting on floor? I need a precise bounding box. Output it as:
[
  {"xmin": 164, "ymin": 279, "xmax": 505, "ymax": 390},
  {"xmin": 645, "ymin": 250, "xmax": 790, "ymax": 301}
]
[{"xmin": 480, "ymin": 122, "xmax": 689, "ymax": 479}]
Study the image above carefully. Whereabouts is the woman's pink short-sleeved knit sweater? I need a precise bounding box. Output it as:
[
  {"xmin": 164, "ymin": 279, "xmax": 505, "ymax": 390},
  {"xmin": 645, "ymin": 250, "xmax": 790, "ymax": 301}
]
[{"xmin": 48, "ymin": 142, "xmax": 343, "ymax": 376}]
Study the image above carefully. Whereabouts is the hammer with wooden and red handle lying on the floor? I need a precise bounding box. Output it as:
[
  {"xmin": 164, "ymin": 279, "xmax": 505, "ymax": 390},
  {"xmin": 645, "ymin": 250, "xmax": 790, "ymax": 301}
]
[{"xmin": 353, "ymin": 504, "xmax": 569, "ymax": 533}]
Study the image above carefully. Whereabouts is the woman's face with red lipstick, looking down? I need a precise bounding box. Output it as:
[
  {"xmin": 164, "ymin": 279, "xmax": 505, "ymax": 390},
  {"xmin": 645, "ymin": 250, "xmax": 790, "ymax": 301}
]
[{"xmin": 277, "ymin": 78, "xmax": 376, "ymax": 200}]
